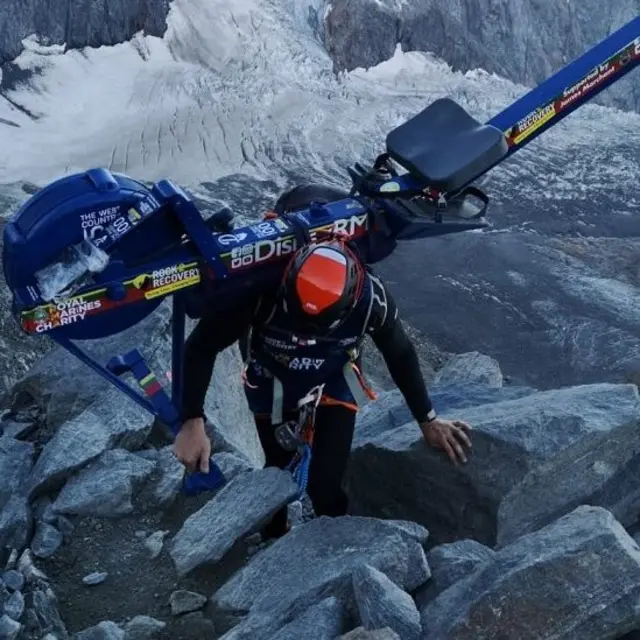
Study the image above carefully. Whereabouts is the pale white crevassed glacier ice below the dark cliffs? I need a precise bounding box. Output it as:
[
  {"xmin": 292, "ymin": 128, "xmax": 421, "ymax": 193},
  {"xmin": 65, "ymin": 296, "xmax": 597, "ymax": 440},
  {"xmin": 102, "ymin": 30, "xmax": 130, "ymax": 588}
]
[{"xmin": 0, "ymin": 0, "xmax": 640, "ymax": 202}]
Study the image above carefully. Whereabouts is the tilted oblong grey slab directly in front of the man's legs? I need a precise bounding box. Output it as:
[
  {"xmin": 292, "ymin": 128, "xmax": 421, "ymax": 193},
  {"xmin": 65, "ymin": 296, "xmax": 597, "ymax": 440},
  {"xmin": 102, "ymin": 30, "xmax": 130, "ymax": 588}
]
[{"xmin": 169, "ymin": 467, "xmax": 298, "ymax": 576}]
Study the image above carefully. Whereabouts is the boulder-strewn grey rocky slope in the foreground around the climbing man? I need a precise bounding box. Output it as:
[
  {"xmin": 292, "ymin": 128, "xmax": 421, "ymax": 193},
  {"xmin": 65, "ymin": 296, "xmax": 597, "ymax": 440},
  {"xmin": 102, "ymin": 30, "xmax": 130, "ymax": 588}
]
[{"xmin": 0, "ymin": 324, "xmax": 640, "ymax": 640}]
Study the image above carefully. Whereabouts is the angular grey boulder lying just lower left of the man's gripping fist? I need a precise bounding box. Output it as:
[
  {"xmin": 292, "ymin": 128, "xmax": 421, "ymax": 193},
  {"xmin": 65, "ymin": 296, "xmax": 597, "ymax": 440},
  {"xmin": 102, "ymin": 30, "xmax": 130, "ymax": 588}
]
[{"xmin": 52, "ymin": 449, "xmax": 156, "ymax": 518}]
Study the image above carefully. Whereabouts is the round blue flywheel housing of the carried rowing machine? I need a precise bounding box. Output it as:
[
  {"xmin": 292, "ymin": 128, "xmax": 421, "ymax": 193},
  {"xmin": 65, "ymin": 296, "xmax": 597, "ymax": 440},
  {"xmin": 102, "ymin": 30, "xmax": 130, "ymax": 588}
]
[{"xmin": 3, "ymin": 169, "xmax": 190, "ymax": 340}]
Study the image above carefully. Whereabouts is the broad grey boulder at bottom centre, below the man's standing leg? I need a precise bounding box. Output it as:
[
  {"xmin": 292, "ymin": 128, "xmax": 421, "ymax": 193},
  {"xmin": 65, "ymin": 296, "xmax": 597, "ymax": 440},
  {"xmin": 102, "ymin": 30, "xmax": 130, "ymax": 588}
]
[{"xmin": 213, "ymin": 516, "xmax": 429, "ymax": 640}]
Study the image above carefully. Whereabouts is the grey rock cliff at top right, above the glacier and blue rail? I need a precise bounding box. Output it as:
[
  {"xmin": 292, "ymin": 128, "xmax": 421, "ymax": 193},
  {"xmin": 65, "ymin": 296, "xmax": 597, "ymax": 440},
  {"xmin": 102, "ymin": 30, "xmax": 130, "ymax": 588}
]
[{"xmin": 322, "ymin": 0, "xmax": 640, "ymax": 110}]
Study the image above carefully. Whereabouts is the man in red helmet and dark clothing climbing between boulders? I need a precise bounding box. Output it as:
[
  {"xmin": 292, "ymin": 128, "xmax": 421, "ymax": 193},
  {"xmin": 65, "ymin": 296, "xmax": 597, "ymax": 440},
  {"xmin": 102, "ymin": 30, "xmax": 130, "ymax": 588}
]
[{"xmin": 174, "ymin": 187, "xmax": 471, "ymax": 537}]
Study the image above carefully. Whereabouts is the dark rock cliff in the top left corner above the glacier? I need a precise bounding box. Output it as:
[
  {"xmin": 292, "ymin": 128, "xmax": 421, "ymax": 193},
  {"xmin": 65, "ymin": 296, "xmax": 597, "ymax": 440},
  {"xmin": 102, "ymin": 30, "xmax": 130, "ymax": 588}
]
[{"xmin": 0, "ymin": 0, "xmax": 170, "ymax": 65}]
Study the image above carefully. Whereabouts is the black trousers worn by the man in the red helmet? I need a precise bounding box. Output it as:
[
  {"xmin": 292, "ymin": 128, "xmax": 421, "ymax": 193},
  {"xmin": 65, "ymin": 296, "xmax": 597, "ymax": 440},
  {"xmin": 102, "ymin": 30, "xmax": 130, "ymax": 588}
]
[{"xmin": 255, "ymin": 405, "xmax": 356, "ymax": 537}]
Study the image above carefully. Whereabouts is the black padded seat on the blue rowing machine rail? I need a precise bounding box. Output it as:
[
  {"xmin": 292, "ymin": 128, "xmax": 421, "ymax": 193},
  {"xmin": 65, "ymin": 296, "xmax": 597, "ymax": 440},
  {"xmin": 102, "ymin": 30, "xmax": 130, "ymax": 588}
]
[{"xmin": 387, "ymin": 98, "xmax": 509, "ymax": 192}]
